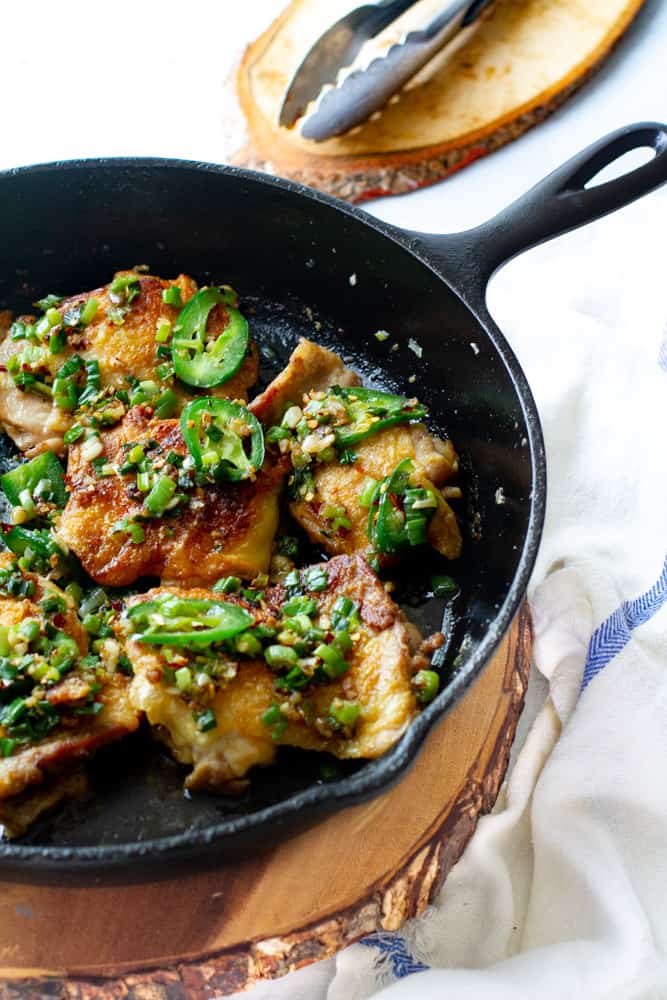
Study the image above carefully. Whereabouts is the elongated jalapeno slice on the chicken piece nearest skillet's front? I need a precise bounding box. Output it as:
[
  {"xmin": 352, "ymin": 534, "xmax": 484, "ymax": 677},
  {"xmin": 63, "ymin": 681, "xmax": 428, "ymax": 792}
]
[{"xmin": 127, "ymin": 594, "xmax": 255, "ymax": 649}]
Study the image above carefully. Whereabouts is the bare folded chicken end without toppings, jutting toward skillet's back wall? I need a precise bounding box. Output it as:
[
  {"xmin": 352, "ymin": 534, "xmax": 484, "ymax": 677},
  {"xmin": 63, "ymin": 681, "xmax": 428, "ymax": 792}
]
[{"xmin": 249, "ymin": 337, "xmax": 361, "ymax": 427}]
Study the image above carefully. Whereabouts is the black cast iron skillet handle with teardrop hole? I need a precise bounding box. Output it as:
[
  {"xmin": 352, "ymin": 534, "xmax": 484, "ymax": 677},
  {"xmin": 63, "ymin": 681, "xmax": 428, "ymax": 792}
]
[{"xmin": 411, "ymin": 122, "xmax": 667, "ymax": 306}]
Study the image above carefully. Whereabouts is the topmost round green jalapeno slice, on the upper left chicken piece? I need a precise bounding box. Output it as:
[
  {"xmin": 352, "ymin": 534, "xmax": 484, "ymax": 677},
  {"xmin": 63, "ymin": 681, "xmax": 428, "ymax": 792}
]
[{"xmin": 171, "ymin": 288, "xmax": 248, "ymax": 389}]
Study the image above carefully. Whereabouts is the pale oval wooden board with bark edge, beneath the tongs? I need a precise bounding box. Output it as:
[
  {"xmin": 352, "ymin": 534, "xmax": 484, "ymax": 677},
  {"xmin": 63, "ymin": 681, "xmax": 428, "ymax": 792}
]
[{"xmin": 234, "ymin": 0, "xmax": 644, "ymax": 202}]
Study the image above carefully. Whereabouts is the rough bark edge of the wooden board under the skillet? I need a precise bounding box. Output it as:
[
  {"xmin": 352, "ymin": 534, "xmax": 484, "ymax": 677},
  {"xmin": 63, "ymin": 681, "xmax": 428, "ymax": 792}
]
[{"xmin": 0, "ymin": 605, "xmax": 532, "ymax": 1000}]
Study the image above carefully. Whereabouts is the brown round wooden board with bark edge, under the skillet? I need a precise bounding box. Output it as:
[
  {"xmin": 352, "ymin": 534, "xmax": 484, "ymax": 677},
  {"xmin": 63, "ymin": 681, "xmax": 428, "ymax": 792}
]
[{"xmin": 0, "ymin": 607, "xmax": 531, "ymax": 1000}]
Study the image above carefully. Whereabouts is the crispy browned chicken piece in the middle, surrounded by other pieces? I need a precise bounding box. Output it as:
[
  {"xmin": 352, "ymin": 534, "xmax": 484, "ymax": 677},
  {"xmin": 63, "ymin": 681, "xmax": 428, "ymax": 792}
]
[{"xmin": 59, "ymin": 406, "xmax": 286, "ymax": 587}]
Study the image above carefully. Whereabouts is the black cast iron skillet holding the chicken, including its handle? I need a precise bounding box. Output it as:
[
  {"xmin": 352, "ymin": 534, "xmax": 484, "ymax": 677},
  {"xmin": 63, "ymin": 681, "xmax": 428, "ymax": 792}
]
[{"xmin": 0, "ymin": 123, "xmax": 667, "ymax": 878}]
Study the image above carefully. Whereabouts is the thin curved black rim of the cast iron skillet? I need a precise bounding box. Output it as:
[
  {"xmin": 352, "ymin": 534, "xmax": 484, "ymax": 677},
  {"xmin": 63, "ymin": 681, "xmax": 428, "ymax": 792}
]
[{"xmin": 0, "ymin": 156, "xmax": 546, "ymax": 872}]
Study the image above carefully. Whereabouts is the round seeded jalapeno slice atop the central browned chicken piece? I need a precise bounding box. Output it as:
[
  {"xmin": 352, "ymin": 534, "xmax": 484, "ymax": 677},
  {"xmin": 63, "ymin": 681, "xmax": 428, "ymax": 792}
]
[{"xmin": 181, "ymin": 396, "xmax": 264, "ymax": 482}]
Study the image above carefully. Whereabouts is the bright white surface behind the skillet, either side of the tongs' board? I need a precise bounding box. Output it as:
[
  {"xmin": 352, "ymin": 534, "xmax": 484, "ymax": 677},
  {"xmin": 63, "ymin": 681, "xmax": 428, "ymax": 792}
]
[{"xmin": 0, "ymin": 0, "xmax": 667, "ymax": 231}]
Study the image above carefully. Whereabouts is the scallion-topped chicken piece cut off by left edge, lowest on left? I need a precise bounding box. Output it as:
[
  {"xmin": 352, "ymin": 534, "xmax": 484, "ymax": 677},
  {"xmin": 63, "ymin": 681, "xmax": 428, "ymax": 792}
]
[{"xmin": 0, "ymin": 553, "xmax": 140, "ymax": 835}]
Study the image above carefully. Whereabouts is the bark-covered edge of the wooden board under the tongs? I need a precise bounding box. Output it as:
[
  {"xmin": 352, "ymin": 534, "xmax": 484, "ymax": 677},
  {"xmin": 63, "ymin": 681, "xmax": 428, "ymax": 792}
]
[{"xmin": 235, "ymin": 0, "xmax": 645, "ymax": 204}]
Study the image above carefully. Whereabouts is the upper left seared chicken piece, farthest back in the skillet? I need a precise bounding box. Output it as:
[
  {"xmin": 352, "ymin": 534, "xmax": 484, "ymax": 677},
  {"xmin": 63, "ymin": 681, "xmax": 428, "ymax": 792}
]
[{"xmin": 0, "ymin": 271, "xmax": 258, "ymax": 454}]
